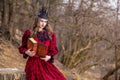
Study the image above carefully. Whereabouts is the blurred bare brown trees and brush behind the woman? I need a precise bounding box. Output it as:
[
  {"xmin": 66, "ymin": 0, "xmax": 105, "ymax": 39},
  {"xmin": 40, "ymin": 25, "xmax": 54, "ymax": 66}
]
[{"xmin": 0, "ymin": 0, "xmax": 120, "ymax": 80}]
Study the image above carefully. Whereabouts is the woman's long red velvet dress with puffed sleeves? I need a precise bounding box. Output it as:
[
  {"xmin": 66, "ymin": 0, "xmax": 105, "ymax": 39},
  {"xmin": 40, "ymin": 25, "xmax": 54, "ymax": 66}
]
[{"xmin": 19, "ymin": 30, "xmax": 66, "ymax": 80}]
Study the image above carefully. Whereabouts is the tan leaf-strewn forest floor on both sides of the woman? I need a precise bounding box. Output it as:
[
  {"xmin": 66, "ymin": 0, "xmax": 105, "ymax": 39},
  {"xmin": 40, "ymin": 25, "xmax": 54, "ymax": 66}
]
[{"xmin": 0, "ymin": 38, "xmax": 114, "ymax": 80}]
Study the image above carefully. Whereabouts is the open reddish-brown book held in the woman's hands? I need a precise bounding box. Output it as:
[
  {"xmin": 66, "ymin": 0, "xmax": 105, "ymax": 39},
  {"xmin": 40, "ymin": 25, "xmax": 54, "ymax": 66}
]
[{"xmin": 27, "ymin": 38, "xmax": 46, "ymax": 57}]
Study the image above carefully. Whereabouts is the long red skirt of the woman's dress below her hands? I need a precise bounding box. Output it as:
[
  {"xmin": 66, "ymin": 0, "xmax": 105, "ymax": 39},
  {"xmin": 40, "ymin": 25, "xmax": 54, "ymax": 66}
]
[{"xmin": 25, "ymin": 57, "xmax": 66, "ymax": 80}]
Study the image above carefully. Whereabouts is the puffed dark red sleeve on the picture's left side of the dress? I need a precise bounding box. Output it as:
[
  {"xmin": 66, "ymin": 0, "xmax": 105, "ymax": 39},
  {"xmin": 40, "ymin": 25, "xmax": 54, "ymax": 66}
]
[{"xmin": 19, "ymin": 30, "xmax": 31, "ymax": 58}]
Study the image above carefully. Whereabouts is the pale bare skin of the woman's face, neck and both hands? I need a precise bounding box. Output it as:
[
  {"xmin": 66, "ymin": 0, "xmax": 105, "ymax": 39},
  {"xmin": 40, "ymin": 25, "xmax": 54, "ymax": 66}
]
[{"xmin": 25, "ymin": 18, "xmax": 51, "ymax": 61}]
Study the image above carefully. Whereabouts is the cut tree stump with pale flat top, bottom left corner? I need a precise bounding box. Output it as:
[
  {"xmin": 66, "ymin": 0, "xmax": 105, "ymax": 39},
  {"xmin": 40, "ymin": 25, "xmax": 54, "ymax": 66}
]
[{"xmin": 0, "ymin": 68, "xmax": 26, "ymax": 80}]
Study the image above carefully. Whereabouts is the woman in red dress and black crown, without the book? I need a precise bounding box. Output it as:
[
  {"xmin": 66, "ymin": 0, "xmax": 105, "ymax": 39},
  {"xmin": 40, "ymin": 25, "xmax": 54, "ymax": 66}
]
[{"xmin": 19, "ymin": 8, "xmax": 66, "ymax": 80}]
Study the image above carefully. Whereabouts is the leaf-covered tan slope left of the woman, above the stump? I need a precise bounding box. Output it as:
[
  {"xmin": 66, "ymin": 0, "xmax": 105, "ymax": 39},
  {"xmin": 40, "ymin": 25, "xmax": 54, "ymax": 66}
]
[{"xmin": 0, "ymin": 38, "xmax": 25, "ymax": 68}]
